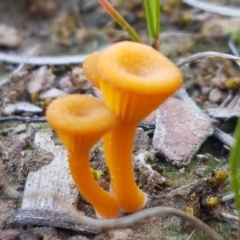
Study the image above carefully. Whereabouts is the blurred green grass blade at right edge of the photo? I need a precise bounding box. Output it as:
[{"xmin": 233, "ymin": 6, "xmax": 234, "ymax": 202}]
[{"xmin": 229, "ymin": 118, "xmax": 240, "ymax": 212}]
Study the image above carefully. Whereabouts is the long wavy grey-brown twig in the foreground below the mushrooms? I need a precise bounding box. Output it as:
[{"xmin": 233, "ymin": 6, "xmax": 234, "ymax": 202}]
[{"xmin": 26, "ymin": 191, "xmax": 223, "ymax": 240}]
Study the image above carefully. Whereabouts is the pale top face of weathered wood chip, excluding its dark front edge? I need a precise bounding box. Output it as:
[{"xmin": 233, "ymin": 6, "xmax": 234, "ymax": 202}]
[{"xmin": 22, "ymin": 133, "xmax": 78, "ymax": 212}]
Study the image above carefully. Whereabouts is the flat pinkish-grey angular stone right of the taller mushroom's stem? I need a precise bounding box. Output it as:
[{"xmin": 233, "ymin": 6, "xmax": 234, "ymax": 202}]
[{"xmin": 153, "ymin": 98, "xmax": 213, "ymax": 167}]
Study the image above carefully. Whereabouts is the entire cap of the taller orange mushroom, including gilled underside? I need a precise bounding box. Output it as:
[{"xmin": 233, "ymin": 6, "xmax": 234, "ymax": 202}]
[{"xmin": 88, "ymin": 41, "xmax": 182, "ymax": 124}]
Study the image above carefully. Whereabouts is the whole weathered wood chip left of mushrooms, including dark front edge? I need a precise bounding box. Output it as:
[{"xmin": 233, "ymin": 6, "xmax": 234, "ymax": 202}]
[{"xmin": 14, "ymin": 133, "xmax": 100, "ymax": 234}]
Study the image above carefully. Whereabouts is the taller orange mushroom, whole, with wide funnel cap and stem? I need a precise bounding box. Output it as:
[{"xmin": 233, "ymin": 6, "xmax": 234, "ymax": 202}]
[{"xmin": 83, "ymin": 41, "xmax": 182, "ymax": 213}]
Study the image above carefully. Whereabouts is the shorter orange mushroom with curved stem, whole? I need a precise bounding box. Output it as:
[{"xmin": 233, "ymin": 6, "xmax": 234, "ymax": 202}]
[{"xmin": 46, "ymin": 94, "xmax": 120, "ymax": 218}]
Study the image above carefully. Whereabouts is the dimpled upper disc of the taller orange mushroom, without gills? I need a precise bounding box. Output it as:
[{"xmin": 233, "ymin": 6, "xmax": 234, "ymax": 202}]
[{"xmin": 98, "ymin": 41, "xmax": 182, "ymax": 95}]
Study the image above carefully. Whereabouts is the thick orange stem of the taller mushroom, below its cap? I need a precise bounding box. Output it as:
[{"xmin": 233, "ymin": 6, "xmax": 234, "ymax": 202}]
[{"xmin": 103, "ymin": 124, "xmax": 147, "ymax": 213}]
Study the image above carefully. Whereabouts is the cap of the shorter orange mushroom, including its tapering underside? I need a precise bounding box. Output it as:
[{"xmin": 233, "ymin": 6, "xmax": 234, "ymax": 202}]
[{"xmin": 46, "ymin": 94, "xmax": 118, "ymax": 150}]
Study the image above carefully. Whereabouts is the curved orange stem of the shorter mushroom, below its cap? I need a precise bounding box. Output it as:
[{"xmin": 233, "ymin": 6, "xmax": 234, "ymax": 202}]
[{"xmin": 69, "ymin": 151, "xmax": 120, "ymax": 218}]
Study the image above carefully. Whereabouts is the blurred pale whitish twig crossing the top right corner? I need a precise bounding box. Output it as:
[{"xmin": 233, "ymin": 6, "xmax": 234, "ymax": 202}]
[{"xmin": 182, "ymin": 0, "xmax": 240, "ymax": 18}]
